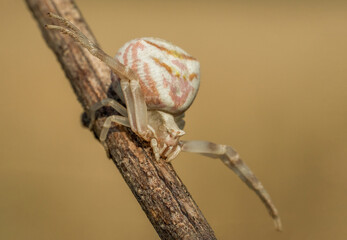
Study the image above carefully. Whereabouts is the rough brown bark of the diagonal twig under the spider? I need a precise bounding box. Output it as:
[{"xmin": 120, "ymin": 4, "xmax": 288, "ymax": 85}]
[{"xmin": 26, "ymin": 0, "xmax": 216, "ymax": 239}]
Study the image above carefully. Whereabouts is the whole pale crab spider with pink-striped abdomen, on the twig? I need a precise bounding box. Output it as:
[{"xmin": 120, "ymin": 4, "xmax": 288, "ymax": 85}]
[{"xmin": 45, "ymin": 13, "xmax": 281, "ymax": 230}]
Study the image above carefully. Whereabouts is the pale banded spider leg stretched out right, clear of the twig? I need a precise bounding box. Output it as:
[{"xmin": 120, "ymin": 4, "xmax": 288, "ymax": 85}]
[{"xmin": 181, "ymin": 141, "xmax": 282, "ymax": 230}]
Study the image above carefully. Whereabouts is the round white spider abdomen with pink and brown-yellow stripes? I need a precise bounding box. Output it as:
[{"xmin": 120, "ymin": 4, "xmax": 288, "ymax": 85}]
[{"xmin": 112, "ymin": 38, "xmax": 200, "ymax": 115}]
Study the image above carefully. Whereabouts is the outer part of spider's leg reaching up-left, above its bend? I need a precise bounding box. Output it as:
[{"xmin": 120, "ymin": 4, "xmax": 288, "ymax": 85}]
[{"xmin": 45, "ymin": 13, "xmax": 136, "ymax": 79}]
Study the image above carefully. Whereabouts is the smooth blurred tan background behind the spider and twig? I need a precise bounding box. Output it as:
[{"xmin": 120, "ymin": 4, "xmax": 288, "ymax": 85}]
[{"xmin": 0, "ymin": 0, "xmax": 347, "ymax": 240}]
